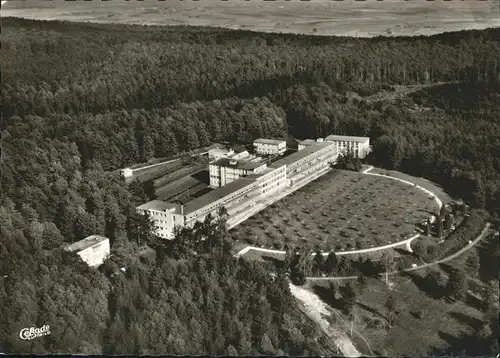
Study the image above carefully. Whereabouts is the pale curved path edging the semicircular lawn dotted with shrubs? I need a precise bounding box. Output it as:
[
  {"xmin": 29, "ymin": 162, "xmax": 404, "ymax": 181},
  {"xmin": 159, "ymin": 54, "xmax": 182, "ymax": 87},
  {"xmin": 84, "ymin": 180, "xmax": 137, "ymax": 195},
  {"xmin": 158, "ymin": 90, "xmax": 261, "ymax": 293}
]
[{"xmin": 234, "ymin": 166, "xmax": 443, "ymax": 257}]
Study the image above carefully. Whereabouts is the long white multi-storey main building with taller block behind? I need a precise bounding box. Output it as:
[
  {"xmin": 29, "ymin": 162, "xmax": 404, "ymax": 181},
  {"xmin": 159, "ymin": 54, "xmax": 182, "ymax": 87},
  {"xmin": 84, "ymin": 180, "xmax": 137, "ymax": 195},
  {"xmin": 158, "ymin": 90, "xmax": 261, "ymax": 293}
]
[{"xmin": 137, "ymin": 138, "xmax": 339, "ymax": 239}]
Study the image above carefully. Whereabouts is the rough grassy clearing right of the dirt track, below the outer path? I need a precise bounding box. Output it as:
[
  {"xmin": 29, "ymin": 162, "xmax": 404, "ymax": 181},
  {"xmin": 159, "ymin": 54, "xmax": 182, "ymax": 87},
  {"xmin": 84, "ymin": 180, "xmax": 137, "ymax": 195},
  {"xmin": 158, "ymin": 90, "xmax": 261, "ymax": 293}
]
[{"xmin": 310, "ymin": 228, "xmax": 498, "ymax": 356}]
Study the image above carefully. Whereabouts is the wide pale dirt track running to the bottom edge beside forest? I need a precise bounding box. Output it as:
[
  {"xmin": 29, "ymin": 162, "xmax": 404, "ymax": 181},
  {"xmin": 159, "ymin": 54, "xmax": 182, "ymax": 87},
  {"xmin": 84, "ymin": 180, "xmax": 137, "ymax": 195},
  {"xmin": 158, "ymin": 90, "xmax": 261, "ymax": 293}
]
[{"xmin": 290, "ymin": 283, "xmax": 361, "ymax": 357}]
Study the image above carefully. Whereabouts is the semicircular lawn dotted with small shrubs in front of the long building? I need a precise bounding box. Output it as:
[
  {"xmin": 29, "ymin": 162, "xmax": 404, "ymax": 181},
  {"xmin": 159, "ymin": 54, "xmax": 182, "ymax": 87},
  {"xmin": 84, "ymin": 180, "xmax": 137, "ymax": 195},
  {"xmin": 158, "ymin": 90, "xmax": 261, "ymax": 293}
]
[{"xmin": 232, "ymin": 170, "xmax": 437, "ymax": 251}]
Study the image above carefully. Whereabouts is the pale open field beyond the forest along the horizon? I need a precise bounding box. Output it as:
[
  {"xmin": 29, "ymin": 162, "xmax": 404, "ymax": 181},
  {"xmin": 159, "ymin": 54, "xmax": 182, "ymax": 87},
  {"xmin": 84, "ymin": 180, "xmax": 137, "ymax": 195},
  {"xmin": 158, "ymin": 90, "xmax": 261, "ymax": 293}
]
[{"xmin": 2, "ymin": 0, "xmax": 500, "ymax": 37}]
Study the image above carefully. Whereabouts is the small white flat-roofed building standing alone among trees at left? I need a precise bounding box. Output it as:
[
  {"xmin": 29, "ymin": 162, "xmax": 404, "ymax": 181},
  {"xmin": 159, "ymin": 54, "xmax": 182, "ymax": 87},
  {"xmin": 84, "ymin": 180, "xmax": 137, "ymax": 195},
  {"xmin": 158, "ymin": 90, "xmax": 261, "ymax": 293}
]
[{"xmin": 64, "ymin": 235, "xmax": 110, "ymax": 267}]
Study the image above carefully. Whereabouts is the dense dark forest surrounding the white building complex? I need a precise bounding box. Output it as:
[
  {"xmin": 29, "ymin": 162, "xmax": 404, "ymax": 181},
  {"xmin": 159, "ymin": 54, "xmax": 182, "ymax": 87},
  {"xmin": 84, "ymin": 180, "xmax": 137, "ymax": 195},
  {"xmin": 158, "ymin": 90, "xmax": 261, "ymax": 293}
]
[{"xmin": 0, "ymin": 18, "xmax": 500, "ymax": 355}]
